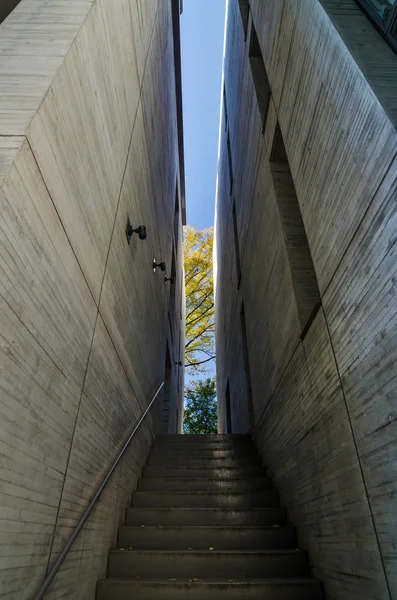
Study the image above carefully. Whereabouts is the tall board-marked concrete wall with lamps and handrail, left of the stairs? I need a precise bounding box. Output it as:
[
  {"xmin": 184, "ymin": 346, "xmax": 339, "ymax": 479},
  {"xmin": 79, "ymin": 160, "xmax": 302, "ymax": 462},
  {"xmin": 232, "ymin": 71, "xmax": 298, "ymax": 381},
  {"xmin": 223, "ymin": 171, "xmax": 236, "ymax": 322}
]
[{"xmin": 0, "ymin": 0, "xmax": 184, "ymax": 600}]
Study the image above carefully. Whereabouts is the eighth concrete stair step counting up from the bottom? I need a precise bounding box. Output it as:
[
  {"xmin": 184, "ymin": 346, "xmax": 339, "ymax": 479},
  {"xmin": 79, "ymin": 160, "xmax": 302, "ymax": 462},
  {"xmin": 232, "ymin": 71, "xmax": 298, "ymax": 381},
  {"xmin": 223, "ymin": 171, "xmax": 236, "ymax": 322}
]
[{"xmin": 147, "ymin": 455, "xmax": 261, "ymax": 469}]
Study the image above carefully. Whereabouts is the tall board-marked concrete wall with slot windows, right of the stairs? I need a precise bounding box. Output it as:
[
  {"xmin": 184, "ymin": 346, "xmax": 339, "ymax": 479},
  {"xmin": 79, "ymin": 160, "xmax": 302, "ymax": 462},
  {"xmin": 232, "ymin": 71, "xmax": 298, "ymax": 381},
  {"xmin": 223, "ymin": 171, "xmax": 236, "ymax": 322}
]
[{"xmin": 216, "ymin": 0, "xmax": 397, "ymax": 600}]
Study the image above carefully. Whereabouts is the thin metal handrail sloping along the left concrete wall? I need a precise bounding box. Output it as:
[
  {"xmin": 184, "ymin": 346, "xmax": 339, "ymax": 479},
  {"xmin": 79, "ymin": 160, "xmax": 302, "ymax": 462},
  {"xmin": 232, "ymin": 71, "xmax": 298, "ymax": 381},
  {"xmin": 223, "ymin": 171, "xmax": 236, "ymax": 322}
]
[{"xmin": 34, "ymin": 381, "xmax": 164, "ymax": 600}]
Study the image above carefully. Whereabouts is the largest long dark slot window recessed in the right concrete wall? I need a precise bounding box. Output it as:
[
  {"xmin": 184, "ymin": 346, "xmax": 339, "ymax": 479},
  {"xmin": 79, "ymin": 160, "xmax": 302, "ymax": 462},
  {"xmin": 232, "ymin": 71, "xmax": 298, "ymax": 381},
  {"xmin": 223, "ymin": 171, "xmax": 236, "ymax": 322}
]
[{"xmin": 270, "ymin": 124, "xmax": 321, "ymax": 339}]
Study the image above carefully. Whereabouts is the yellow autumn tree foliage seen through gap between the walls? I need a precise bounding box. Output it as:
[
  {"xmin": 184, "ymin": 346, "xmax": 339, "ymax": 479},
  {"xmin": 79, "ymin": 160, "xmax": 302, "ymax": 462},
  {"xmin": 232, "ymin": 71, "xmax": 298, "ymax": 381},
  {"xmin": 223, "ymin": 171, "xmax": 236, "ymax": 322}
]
[{"xmin": 184, "ymin": 227, "xmax": 215, "ymax": 372}]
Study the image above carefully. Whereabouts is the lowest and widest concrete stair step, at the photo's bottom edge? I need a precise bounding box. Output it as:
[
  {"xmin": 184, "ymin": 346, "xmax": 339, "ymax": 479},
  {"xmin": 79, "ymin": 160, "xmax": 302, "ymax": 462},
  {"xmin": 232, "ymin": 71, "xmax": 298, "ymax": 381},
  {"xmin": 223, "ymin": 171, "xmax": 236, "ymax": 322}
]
[{"xmin": 97, "ymin": 578, "xmax": 323, "ymax": 600}]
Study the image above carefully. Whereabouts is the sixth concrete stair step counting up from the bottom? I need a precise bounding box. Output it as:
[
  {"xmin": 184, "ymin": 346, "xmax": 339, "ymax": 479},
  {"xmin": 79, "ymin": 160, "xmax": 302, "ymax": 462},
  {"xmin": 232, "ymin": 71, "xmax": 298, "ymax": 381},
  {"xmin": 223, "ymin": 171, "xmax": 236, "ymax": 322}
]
[{"xmin": 138, "ymin": 477, "xmax": 272, "ymax": 493}]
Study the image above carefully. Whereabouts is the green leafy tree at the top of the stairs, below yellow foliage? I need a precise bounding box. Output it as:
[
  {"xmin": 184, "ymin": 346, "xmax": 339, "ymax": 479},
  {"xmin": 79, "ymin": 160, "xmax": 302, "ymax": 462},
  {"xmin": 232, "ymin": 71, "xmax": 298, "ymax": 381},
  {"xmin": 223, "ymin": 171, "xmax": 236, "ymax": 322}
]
[{"xmin": 183, "ymin": 378, "xmax": 218, "ymax": 434}]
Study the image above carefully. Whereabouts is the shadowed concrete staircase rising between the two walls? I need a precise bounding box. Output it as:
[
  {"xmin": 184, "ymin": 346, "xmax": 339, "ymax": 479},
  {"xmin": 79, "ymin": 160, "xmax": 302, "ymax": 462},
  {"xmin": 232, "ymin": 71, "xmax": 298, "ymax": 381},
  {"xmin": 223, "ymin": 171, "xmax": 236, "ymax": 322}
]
[{"xmin": 97, "ymin": 435, "xmax": 322, "ymax": 600}]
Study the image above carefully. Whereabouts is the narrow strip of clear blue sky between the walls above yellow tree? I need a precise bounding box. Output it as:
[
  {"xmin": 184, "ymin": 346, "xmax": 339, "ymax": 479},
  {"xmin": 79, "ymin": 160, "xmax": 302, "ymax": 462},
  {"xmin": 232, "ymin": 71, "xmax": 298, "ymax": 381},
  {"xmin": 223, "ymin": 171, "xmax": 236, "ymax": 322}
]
[{"xmin": 181, "ymin": 0, "xmax": 226, "ymax": 229}]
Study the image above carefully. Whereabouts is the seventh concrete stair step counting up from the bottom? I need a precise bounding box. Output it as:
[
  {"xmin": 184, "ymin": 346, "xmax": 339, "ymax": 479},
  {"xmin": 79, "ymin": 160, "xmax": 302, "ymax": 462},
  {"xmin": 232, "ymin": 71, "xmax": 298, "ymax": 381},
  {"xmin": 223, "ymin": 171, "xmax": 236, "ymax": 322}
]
[{"xmin": 143, "ymin": 465, "xmax": 266, "ymax": 479}]
